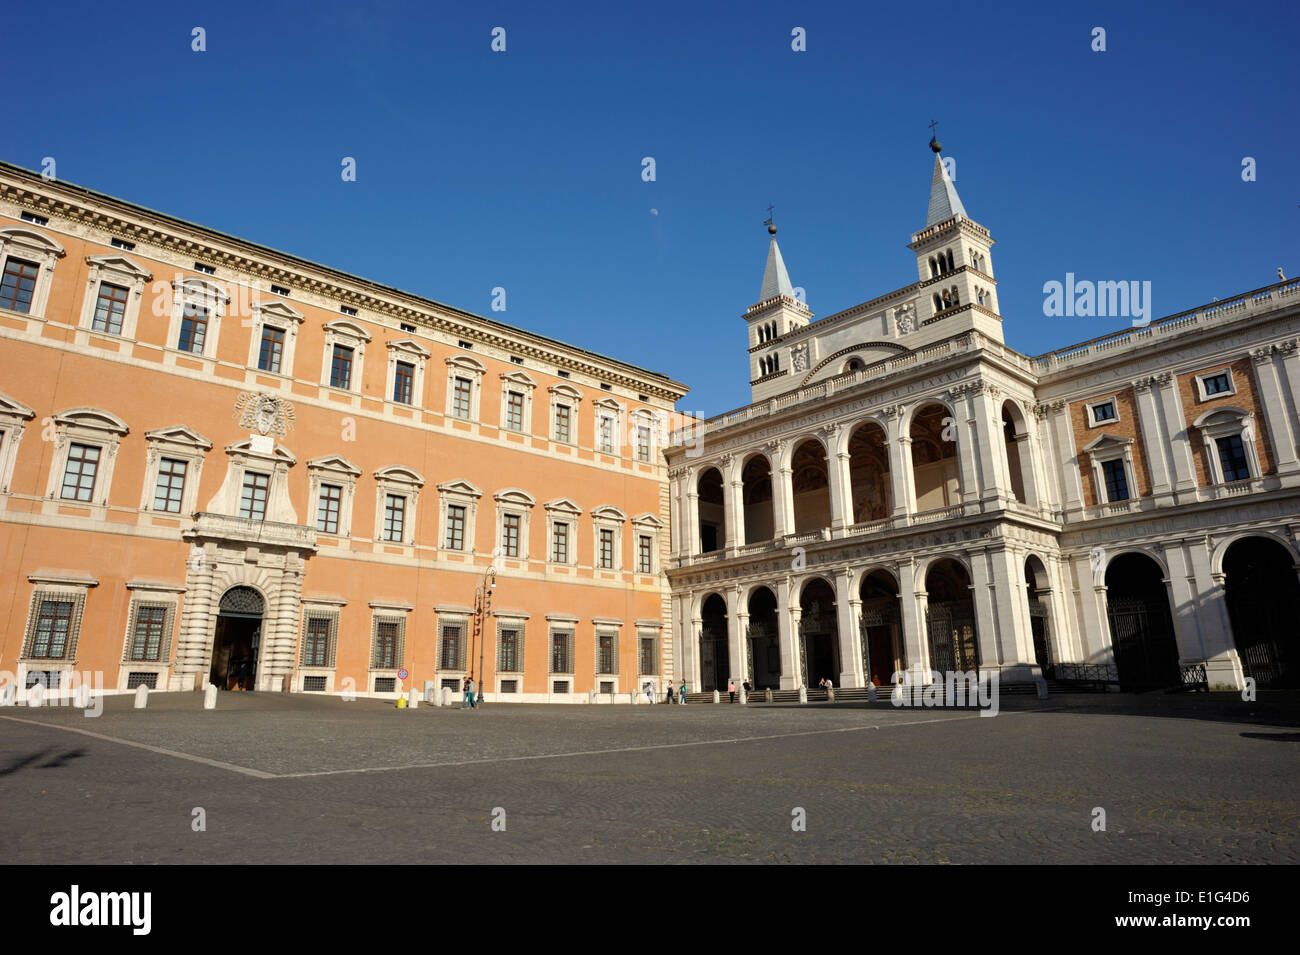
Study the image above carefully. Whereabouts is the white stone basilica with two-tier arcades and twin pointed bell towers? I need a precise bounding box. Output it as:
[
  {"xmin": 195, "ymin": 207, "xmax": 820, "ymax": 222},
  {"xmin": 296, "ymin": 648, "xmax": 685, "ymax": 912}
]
[{"xmin": 666, "ymin": 143, "xmax": 1300, "ymax": 691}]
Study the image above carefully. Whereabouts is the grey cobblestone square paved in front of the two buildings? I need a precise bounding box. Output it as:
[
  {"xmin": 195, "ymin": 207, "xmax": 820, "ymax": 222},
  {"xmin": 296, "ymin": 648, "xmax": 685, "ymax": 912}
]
[{"xmin": 0, "ymin": 694, "xmax": 1300, "ymax": 864}]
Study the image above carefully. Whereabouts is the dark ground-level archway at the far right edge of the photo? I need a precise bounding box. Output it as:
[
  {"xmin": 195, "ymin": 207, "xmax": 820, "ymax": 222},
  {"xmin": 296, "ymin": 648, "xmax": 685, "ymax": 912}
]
[{"xmin": 1223, "ymin": 537, "xmax": 1300, "ymax": 689}]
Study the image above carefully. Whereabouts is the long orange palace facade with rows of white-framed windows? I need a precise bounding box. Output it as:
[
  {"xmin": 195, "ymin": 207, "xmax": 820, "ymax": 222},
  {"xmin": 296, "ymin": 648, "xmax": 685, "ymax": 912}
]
[{"xmin": 0, "ymin": 165, "xmax": 686, "ymax": 702}]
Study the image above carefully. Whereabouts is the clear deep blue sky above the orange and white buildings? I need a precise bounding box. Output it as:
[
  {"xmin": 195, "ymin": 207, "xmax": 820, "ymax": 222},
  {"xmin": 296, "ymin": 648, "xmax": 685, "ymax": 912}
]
[{"xmin": 0, "ymin": 0, "xmax": 1300, "ymax": 414}]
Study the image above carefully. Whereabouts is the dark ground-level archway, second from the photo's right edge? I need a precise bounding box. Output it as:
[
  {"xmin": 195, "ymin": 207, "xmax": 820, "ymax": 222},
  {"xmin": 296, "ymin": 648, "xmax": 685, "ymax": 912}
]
[{"xmin": 1106, "ymin": 554, "xmax": 1182, "ymax": 690}]
